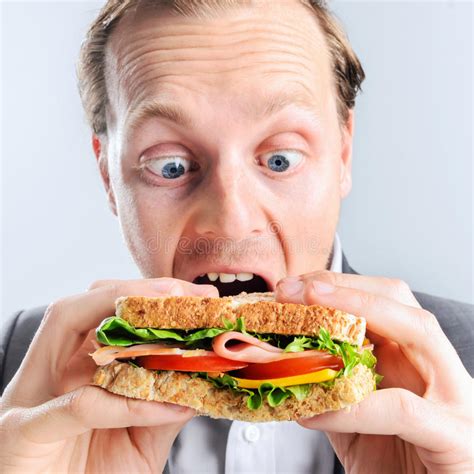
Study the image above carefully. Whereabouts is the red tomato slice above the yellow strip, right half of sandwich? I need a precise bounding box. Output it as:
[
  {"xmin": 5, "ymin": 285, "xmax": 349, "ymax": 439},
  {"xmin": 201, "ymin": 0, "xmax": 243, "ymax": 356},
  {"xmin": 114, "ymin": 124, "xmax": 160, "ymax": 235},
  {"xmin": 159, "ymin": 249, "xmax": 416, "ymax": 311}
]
[{"xmin": 231, "ymin": 354, "xmax": 344, "ymax": 380}]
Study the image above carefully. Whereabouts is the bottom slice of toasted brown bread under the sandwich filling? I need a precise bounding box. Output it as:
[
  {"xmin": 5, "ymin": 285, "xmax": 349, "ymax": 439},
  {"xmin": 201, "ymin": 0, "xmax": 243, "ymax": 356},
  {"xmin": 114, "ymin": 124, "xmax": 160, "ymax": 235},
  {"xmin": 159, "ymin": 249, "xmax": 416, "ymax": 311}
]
[{"xmin": 93, "ymin": 362, "xmax": 375, "ymax": 422}]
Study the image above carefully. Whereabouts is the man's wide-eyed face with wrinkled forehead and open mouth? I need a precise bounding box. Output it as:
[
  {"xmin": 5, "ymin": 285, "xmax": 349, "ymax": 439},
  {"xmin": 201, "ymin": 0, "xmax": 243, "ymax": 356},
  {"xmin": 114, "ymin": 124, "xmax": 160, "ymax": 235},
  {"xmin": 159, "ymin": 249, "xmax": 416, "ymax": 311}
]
[{"xmin": 101, "ymin": 1, "xmax": 352, "ymax": 294}]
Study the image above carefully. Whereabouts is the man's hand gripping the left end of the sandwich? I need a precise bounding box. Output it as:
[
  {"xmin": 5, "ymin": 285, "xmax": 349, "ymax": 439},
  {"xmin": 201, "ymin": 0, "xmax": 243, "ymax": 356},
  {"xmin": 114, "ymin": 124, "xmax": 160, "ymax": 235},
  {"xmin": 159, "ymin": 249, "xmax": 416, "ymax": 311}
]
[{"xmin": 0, "ymin": 278, "xmax": 219, "ymax": 473}]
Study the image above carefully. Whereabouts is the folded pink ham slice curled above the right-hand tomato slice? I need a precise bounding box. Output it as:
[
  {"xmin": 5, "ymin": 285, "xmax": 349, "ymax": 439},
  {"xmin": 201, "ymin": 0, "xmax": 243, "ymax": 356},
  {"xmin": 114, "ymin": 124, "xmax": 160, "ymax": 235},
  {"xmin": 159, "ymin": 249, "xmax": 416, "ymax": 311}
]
[{"xmin": 212, "ymin": 331, "xmax": 332, "ymax": 364}]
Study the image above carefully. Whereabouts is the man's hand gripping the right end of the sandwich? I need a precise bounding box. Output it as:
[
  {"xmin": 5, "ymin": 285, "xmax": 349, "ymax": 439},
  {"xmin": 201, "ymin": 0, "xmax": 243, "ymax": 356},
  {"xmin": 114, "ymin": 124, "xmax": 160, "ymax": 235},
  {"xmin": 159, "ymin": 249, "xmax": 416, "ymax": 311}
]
[{"xmin": 276, "ymin": 271, "xmax": 473, "ymax": 474}]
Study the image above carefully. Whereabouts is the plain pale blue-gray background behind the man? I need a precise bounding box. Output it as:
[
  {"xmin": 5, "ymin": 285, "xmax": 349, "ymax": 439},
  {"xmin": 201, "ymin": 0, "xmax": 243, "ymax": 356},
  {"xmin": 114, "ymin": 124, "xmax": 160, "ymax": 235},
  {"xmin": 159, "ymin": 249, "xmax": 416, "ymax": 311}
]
[{"xmin": 0, "ymin": 1, "xmax": 473, "ymax": 317}]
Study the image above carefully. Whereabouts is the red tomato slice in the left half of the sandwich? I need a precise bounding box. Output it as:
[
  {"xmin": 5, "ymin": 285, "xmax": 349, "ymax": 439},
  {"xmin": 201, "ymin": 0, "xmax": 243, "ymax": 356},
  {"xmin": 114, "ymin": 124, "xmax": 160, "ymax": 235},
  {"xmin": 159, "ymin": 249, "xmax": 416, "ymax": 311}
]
[{"xmin": 136, "ymin": 351, "xmax": 248, "ymax": 372}]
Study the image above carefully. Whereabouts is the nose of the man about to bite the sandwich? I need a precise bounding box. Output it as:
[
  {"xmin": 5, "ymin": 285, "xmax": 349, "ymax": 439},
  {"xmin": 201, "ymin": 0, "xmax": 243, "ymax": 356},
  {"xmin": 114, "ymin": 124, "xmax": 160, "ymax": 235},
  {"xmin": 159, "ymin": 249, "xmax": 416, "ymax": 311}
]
[{"xmin": 194, "ymin": 157, "xmax": 266, "ymax": 241}]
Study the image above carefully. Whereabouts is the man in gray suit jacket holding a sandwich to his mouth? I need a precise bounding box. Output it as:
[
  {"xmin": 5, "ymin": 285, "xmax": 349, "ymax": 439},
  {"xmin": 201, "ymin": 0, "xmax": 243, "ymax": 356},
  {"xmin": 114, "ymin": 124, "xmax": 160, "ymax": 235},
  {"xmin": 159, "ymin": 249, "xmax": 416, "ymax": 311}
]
[{"xmin": 0, "ymin": 0, "xmax": 473, "ymax": 473}]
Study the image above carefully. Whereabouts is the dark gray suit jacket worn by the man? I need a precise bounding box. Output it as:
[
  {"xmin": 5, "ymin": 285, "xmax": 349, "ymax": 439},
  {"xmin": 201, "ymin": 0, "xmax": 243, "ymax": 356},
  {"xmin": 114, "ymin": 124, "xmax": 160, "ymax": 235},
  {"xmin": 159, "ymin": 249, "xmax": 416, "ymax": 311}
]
[{"xmin": 0, "ymin": 254, "xmax": 474, "ymax": 474}]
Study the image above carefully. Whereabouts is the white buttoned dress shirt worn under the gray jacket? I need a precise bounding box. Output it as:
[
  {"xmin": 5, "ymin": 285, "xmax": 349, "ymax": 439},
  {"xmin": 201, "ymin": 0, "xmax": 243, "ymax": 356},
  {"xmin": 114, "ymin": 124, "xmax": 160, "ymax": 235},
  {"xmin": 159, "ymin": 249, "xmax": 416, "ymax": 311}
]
[{"xmin": 167, "ymin": 233, "xmax": 342, "ymax": 474}]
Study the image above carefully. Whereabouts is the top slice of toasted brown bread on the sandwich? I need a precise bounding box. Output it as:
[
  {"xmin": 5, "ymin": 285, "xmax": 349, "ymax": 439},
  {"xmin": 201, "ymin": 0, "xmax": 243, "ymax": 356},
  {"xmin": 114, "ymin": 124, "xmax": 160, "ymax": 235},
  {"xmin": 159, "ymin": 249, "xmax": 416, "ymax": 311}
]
[{"xmin": 116, "ymin": 292, "xmax": 365, "ymax": 346}]
